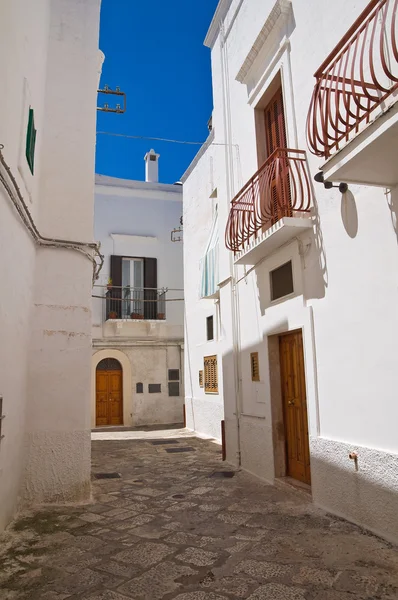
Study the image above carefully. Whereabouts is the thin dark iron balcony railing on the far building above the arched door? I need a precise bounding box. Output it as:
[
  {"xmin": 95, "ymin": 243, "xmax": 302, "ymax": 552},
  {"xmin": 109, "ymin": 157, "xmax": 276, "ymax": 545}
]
[{"xmin": 94, "ymin": 285, "xmax": 168, "ymax": 321}]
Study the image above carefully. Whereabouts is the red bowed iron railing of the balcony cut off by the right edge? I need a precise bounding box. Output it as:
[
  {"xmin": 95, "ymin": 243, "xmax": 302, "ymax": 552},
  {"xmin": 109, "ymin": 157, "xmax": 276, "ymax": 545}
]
[{"xmin": 307, "ymin": 0, "xmax": 398, "ymax": 158}]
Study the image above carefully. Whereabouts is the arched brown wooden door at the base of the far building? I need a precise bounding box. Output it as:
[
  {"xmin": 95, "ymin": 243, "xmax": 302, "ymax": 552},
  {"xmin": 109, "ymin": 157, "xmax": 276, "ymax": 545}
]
[{"xmin": 95, "ymin": 358, "xmax": 123, "ymax": 427}]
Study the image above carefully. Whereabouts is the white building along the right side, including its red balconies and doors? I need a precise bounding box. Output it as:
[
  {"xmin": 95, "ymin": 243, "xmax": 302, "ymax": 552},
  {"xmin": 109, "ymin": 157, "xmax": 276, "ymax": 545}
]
[{"xmin": 183, "ymin": 0, "xmax": 398, "ymax": 541}]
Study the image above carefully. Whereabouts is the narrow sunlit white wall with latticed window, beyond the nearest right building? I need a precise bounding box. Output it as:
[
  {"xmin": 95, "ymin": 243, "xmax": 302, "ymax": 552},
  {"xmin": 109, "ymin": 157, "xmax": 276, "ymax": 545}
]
[{"xmin": 183, "ymin": 135, "xmax": 225, "ymax": 439}]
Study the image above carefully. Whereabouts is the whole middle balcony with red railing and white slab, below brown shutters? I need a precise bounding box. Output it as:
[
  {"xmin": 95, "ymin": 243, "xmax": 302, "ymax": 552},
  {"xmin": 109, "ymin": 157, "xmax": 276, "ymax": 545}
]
[{"xmin": 225, "ymin": 148, "xmax": 312, "ymax": 265}]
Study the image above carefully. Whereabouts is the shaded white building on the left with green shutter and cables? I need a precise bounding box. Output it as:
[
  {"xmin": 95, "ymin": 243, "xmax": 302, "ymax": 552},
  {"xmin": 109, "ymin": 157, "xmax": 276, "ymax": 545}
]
[{"xmin": 0, "ymin": 0, "xmax": 100, "ymax": 529}]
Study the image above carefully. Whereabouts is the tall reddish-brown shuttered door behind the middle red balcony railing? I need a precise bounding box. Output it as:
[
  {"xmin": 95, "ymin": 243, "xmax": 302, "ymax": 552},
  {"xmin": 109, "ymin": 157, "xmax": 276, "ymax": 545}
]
[{"xmin": 264, "ymin": 87, "xmax": 292, "ymax": 224}]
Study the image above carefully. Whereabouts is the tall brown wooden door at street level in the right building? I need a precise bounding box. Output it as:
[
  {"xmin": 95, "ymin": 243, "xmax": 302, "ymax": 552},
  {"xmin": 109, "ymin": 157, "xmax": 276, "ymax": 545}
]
[{"xmin": 279, "ymin": 331, "xmax": 311, "ymax": 484}]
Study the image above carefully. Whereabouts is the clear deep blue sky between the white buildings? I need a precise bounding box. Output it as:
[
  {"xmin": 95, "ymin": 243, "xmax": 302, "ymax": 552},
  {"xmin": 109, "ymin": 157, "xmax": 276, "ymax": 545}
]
[{"xmin": 96, "ymin": 0, "xmax": 218, "ymax": 183}]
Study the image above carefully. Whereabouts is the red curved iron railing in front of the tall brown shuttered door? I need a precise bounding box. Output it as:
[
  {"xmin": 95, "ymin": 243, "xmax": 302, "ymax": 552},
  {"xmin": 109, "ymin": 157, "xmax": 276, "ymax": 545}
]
[{"xmin": 225, "ymin": 148, "xmax": 312, "ymax": 252}]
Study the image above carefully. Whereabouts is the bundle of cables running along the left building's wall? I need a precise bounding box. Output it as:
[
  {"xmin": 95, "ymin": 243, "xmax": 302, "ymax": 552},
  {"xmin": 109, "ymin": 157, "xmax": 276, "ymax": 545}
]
[{"xmin": 0, "ymin": 144, "xmax": 104, "ymax": 283}]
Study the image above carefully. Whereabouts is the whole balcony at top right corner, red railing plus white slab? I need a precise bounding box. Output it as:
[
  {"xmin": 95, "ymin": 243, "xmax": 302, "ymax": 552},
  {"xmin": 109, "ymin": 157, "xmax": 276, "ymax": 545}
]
[{"xmin": 307, "ymin": 0, "xmax": 398, "ymax": 186}]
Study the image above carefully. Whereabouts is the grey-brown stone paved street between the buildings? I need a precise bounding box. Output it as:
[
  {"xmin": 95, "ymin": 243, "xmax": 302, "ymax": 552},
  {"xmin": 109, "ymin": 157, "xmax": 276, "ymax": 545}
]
[{"xmin": 0, "ymin": 433, "xmax": 398, "ymax": 600}]
